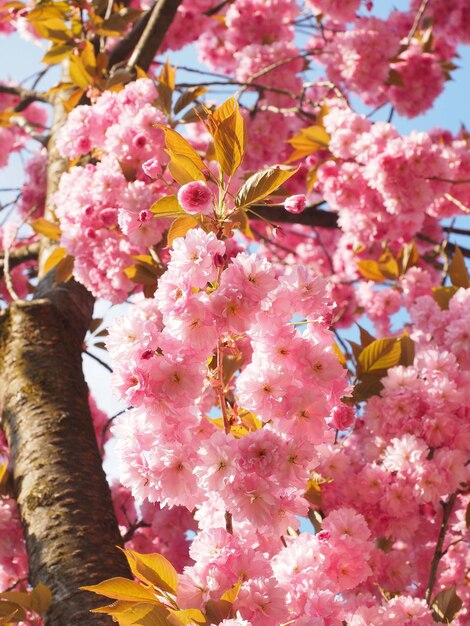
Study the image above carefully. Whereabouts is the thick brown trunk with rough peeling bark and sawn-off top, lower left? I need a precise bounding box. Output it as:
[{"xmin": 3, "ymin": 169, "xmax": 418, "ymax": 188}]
[{"xmin": 0, "ymin": 282, "xmax": 129, "ymax": 626}]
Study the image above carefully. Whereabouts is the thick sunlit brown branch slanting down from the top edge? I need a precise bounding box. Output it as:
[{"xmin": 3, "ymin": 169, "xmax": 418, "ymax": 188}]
[{"xmin": 126, "ymin": 0, "xmax": 183, "ymax": 71}]
